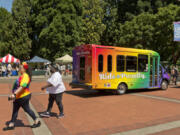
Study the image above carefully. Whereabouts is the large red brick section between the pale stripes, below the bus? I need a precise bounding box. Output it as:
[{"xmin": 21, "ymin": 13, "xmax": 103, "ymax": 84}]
[{"xmin": 28, "ymin": 81, "xmax": 180, "ymax": 135}]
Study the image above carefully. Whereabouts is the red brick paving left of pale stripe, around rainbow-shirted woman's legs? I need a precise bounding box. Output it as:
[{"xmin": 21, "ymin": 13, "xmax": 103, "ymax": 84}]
[{"xmin": 0, "ymin": 83, "xmax": 33, "ymax": 135}]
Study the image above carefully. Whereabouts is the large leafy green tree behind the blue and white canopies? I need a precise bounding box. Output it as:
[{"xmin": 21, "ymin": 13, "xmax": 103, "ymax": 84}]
[{"xmin": 31, "ymin": 0, "xmax": 82, "ymax": 60}]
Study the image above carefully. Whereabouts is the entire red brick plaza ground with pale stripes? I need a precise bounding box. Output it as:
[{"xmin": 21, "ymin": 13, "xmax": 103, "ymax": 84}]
[{"xmin": 0, "ymin": 79, "xmax": 180, "ymax": 135}]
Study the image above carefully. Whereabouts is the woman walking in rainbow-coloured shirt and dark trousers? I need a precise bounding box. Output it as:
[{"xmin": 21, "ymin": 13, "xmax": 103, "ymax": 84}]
[{"xmin": 4, "ymin": 62, "xmax": 41, "ymax": 130}]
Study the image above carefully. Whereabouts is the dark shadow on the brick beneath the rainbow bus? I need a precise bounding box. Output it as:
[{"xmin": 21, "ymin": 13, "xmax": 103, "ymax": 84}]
[{"xmin": 65, "ymin": 89, "xmax": 162, "ymax": 98}]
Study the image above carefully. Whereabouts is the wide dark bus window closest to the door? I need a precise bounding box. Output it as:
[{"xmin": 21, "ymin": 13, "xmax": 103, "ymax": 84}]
[{"xmin": 138, "ymin": 54, "xmax": 148, "ymax": 72}]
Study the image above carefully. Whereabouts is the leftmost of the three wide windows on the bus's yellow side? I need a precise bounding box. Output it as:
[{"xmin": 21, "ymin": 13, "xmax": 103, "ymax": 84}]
[{"xmin": 116, "ymin": 55, "xmax": 125, "ymax": 72}]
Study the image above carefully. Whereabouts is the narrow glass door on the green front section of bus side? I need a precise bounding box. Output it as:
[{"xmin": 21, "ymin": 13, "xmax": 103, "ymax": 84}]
[{"xmin": 149, "ymin": 56, "xmax": 159, "ymax": 87}]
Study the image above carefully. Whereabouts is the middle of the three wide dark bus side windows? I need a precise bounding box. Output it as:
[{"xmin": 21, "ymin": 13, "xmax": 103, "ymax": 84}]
[{"xmin": 126, "ymin": 56, "xmax": 137, "ymax": 72}]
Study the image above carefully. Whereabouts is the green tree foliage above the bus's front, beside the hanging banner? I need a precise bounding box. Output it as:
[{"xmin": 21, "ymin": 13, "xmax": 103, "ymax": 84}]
[{"xmin": 113, "ymin": 5, "xmax": 180, "ymax": 63}]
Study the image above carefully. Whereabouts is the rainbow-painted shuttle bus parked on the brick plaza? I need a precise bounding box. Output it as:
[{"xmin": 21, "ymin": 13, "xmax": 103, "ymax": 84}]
[{"xmin": 70, "ymin": 44, "xmax": 170, "ymax": 94}]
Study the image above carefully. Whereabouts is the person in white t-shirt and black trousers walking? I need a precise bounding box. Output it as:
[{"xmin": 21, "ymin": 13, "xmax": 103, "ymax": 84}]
[{"xmin": 40, "ymin": 65, "xmax": 66, "ymax": 118}]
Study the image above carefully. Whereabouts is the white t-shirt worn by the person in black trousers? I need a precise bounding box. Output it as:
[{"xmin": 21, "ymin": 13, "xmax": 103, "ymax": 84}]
[{"xmin": 47, "ymin": 72, "xmax": 66, "ymax": 94}]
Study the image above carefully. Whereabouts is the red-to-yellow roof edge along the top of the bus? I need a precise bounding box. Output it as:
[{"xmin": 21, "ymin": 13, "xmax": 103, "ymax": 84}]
[{"xmin": 75, "ymin": 44, "xmax": 159, "ymax": 56}]
